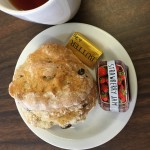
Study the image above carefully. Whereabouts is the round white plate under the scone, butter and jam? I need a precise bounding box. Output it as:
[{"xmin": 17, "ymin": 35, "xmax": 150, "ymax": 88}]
[{"xmin": 16, "ymin": 23, "xmax": 137, "ymax": 149}]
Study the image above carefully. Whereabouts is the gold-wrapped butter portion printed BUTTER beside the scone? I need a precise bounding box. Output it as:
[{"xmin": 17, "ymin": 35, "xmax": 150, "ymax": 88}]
[{"xmin": 66, "ymin": 32, "xmax": 103, "ymax": 67}]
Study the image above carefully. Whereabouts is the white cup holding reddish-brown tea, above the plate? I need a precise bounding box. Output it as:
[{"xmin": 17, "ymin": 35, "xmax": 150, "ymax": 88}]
[{"xmin": 0, "ymin": 0, "xmax": 81, "ymax": 25}]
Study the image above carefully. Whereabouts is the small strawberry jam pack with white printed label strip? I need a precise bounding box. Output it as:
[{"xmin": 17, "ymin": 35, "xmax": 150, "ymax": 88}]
[{"xmin": 97, "ymin": 60, "xmax": 129, "ymax": 112}]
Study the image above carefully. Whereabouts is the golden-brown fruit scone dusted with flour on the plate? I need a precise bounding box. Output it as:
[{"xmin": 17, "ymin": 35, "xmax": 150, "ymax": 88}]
[{"xmin": 9, "ymin": 43, "xmax": 97, "ymax": 128}]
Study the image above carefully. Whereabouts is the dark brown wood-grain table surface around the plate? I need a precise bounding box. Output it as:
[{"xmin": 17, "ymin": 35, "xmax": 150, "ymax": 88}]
[{"xmin": 0, "ymin": 0, "xmax": 150, "ymax": 150}]
